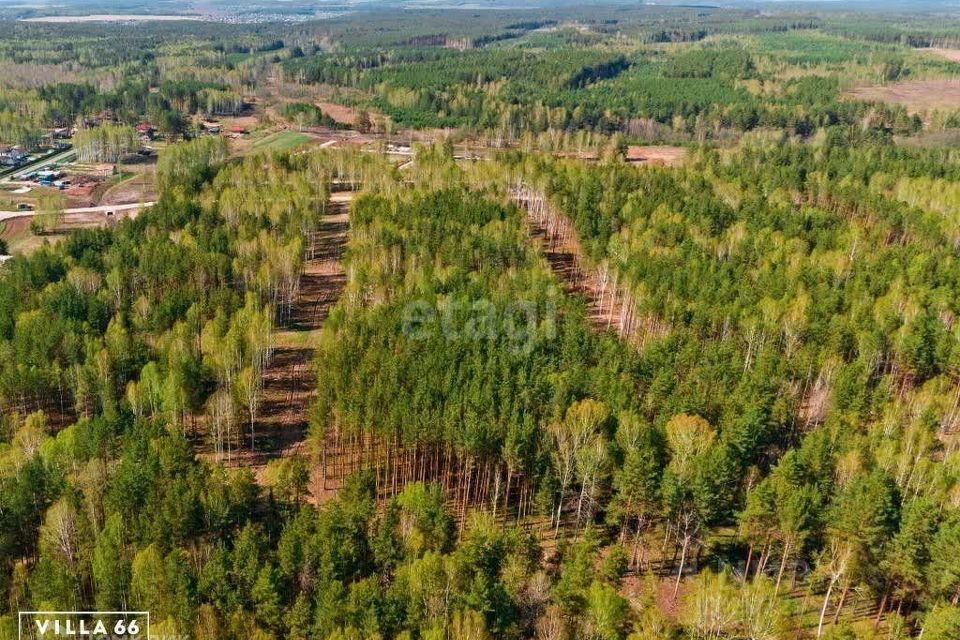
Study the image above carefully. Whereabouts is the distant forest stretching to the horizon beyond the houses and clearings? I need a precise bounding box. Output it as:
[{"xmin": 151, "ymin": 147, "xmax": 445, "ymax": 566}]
[{"xmin": 0, "ymin": 6, "xmax": 960, "ymax": 151}]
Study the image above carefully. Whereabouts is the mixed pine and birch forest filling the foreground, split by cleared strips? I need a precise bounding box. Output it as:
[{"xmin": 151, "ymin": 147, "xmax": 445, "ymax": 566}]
[{"xmin": 2, "ymin": 138, "xmax": 960, "ymax": 638}]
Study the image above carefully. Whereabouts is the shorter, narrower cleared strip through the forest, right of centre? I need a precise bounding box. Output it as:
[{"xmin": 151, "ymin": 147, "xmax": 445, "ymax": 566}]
[{"xmin": 513, "ymin": 188, "xmax": 670, "ymax": 347}]
